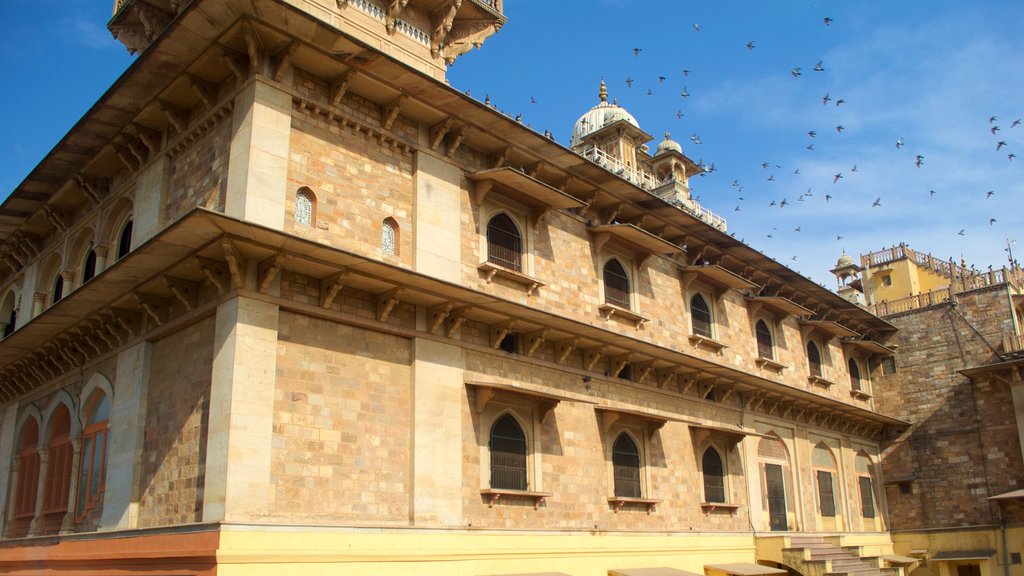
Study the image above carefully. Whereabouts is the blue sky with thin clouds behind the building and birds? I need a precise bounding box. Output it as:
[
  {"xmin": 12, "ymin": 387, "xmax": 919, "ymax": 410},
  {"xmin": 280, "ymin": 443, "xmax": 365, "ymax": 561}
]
[{"xmin": 0, "ymin": 0, "xmax": 1024, "ymax": 287}]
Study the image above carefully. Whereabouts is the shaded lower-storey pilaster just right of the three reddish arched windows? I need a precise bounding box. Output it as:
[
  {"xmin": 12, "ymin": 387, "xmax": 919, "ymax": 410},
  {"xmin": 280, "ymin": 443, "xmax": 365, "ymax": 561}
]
[{"xmin": 100, "ymin": 341, "xmax": 152, "ymax": 530}]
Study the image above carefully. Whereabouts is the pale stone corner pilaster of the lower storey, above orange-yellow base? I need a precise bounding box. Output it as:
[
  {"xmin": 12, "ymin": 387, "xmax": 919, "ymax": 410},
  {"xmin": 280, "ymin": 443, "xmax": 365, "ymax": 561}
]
[{"xmin": 202, "ymin": 296, "xmax": 280, "ymax": 522}]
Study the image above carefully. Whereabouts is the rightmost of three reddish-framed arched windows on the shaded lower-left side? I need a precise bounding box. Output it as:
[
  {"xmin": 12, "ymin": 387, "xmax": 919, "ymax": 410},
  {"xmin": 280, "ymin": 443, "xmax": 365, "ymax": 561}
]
[{"xmin": 75, "ymin": 390, "xmax": 111, "ymax": 521}]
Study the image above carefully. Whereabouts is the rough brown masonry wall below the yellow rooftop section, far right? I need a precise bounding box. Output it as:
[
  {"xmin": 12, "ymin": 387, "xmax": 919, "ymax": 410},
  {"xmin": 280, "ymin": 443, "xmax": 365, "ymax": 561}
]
[{"xmin": 876, "ymin": 285, "xmax": 1024, "ymax": 529}]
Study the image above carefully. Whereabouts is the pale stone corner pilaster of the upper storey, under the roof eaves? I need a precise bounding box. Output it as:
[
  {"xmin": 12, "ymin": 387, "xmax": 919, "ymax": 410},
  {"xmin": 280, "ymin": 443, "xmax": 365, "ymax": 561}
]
[{"xmin": 224, "ymin": 77, "xmax": 292, "ymax": 230}]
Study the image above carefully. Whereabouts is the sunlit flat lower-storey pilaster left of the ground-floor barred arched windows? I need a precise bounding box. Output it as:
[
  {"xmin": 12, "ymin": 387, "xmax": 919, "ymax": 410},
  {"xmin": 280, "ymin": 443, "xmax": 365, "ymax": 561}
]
[{"xmin": 411, "ymin": 338, "xmax": 466, "ymax": 526}]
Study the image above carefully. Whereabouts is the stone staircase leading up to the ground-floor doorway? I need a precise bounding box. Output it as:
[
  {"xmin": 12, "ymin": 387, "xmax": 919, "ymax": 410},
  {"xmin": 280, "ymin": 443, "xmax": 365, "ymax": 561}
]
[{"xmin": 782, "ymin": 536, "xmax": 903, "ymax": 576}]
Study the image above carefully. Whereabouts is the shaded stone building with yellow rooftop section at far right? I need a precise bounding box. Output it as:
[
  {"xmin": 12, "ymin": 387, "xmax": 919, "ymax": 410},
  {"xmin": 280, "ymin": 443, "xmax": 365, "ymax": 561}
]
[{"xmin": 833, "ymin": 244, "xmax": 1024, "ymax": 576}]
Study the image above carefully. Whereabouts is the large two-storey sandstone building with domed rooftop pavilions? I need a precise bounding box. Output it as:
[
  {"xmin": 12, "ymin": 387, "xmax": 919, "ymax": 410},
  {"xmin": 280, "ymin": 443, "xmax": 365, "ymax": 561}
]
[{"xmin": 0, "ymin": 0, "xmax": 946, "ymax": 576}]
